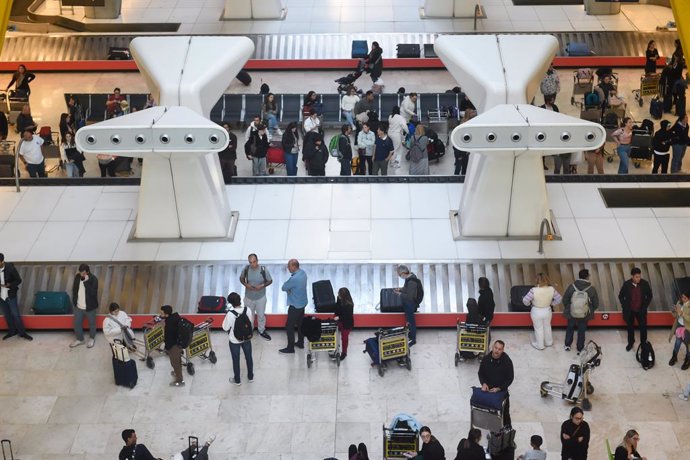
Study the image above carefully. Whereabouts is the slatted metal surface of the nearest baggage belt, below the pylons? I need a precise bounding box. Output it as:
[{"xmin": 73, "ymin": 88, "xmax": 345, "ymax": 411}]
[{"xmin": 16, "ymin": 258, "xmax": 690, "ymax": 314}]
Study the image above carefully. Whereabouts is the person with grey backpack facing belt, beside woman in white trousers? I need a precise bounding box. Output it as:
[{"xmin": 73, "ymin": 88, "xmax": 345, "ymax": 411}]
[{"xmin": 563, "ymin": 268, "xmax": 599, "ymax": 355}]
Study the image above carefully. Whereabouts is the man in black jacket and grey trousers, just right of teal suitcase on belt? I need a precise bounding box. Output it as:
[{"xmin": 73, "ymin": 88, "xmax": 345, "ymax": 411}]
[{"xmin": 70, "ymin": 264, "xmax": 98, "ymax": 348}]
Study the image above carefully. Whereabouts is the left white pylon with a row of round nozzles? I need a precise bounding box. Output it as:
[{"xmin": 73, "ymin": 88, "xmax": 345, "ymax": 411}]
[{"xmin": 76, "ymin": 36, "xmax": 254, "ymax": 239}]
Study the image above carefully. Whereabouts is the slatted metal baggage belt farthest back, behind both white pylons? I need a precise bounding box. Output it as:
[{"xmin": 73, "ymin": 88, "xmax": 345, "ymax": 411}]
[{"xmin": 0, "ymin": 31, "xmax": 678, "ymax": 62}]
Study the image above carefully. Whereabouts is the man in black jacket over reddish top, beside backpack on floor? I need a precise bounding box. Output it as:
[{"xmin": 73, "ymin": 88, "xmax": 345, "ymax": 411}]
[{"xmin": 618, "ymin": 267, "xmax": 652, "ymax": 351}]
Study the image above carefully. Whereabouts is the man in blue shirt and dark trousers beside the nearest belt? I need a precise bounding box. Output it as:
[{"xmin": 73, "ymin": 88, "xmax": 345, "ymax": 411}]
[{"xmin": 278, "ymin": 259, "xmax": 308, "ymax": 353}]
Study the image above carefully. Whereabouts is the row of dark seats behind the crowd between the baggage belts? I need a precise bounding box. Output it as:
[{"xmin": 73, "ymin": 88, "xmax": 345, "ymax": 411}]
[{"xmin": 65, "ymin": 93, "xmax": 462, "ymax": 127}]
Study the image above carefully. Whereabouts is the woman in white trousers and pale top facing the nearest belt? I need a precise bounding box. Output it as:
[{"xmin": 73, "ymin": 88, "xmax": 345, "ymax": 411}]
[{"xmin": 522, "ymin": 273, "xmax": 561, "ymax": 350}]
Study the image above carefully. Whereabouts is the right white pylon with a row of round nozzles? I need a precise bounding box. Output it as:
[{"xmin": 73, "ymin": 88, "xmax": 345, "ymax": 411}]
[{"xmin": 434, "ymin": 35, "xmax": 605, "ymax": 238}]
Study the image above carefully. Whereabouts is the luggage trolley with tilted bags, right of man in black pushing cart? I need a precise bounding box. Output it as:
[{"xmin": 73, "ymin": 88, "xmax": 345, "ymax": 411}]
[{"xmin": 539, "ymin": 340, "xmax": 601, "ymax": 410}]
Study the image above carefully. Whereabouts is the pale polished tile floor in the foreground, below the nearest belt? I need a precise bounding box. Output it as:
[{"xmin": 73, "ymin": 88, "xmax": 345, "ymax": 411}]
[{"xmin": 0, "ymin": 329, "xmax": 690, "ymax": 460}]
